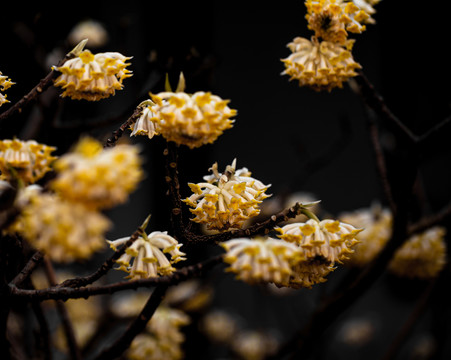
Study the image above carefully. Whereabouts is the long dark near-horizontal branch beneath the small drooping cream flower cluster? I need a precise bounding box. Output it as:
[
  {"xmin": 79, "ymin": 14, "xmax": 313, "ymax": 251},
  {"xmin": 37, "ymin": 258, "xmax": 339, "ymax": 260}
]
[{"xmin": 9, "ymin": 255, "xmax": 223, "ymax": 301}]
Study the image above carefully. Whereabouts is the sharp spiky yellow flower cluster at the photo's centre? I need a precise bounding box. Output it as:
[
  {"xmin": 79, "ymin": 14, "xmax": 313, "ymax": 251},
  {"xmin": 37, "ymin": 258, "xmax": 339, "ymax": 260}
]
[{"xmin": 183, "ymin": 159, "xmax": 271, "ymax": 231}]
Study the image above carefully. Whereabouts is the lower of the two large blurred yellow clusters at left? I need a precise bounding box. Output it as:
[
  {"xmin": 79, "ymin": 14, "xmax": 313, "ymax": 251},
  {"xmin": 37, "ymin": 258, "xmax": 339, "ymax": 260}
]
[{"xmin": 8, "ymin": 185, "xmax": 111, "ymax": 262}]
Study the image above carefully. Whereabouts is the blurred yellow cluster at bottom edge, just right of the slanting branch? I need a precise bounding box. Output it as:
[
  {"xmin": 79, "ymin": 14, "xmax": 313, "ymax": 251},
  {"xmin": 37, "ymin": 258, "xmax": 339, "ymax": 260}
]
[{"xmin": 127, "ymin": 306, "xmax": 191, "ymax": 360}]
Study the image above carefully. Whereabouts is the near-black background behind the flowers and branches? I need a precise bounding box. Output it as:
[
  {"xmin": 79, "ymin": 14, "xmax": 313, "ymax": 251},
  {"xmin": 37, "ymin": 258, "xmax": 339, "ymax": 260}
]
[{"xmin": 0, "ymin": 0, "xmax": 451, "ymax": 359}]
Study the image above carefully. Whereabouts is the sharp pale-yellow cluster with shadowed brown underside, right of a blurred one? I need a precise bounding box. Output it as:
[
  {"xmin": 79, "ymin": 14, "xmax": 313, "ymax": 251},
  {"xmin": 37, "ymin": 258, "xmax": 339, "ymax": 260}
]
[{"xmin": 276, "ymin": 219, "xmax": 362, "ymax": 288}]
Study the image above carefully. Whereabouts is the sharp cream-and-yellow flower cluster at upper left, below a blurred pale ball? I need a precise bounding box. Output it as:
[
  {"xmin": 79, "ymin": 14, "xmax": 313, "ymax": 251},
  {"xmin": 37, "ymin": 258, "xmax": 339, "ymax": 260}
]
[{"xmin": 54, "ymin": 50, "xmax": 132, "ymax": 101}]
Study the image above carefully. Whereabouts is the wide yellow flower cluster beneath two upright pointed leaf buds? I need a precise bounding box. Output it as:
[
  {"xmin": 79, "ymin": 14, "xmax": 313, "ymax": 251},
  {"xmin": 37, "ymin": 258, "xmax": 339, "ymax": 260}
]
[{"xmin": 151, "ymin": 91, "xmax": 237, "ymax": 149}]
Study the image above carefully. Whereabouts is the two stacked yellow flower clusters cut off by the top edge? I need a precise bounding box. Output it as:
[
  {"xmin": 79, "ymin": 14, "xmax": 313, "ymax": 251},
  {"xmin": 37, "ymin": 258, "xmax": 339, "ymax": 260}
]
[{"xmin": 282, "ymin": 0, "xmax": 382, "ymax": 91}]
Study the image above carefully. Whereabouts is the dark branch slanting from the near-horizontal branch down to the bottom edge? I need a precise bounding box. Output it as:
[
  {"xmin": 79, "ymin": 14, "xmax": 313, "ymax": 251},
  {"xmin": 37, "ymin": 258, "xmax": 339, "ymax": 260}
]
[{"xmin": 94, "ymin": 285, "xmax": 168, "ymax": 360}]
